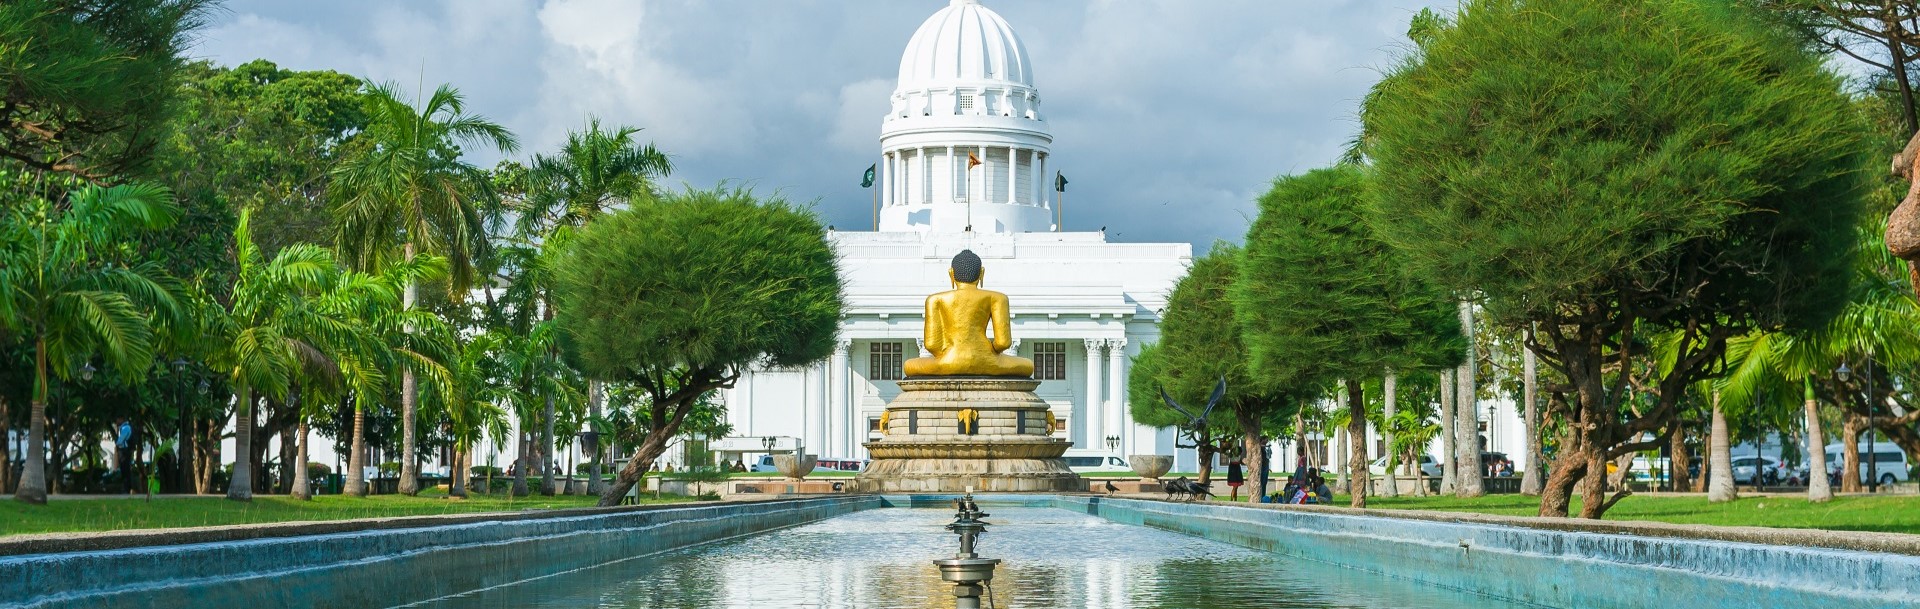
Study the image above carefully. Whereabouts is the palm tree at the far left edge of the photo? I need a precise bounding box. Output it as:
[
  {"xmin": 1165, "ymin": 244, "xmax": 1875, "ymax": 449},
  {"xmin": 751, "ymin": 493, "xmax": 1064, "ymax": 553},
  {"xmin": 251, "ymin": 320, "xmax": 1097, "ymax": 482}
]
[{"xmin": 0, "ymin": 183, "xmax": 179, "ymax": 503}]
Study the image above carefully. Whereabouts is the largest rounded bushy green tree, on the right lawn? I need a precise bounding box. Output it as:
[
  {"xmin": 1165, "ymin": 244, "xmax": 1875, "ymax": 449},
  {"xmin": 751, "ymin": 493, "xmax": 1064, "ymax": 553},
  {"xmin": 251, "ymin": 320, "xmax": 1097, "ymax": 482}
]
[{"xmin": 1361, "ymin": 0, "xmax": 1868, "ymax": 517}]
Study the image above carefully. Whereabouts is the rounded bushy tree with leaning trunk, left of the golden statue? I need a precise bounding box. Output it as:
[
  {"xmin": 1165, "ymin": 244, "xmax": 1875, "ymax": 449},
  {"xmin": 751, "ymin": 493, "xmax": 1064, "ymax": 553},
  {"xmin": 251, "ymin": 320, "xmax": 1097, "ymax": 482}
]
[{"xmin": 553, "ymin": 186, "xmax": 845, "ymax": 503}]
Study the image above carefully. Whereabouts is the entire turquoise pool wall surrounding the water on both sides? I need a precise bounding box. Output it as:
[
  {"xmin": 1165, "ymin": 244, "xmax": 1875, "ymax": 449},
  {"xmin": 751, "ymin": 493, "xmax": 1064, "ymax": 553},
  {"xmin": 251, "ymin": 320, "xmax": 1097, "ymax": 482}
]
[{"xmin": 0, "ymin": 494, "xmax": 1920, "ymax": 609}]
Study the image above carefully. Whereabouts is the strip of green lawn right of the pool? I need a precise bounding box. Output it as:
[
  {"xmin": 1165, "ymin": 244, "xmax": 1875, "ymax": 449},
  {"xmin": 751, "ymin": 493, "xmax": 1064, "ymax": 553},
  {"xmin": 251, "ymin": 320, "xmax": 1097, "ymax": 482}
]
[{"xmin": 1332, "ymin": 494, "xmax": 1920, "ymax": 534}]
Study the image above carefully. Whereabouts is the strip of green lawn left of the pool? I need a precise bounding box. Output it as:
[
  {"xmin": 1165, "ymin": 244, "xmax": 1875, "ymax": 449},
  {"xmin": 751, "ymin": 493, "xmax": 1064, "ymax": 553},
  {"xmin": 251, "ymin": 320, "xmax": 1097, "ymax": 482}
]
[{"xmin": 0, "ymin": 490, "xmax": 687, "ymax": 536}]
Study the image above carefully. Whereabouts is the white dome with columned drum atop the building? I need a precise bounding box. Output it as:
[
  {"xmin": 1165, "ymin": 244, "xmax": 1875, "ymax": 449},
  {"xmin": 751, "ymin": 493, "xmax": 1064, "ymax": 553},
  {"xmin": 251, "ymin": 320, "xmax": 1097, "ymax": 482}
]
[{"xmin": 879, "ymin": 0, "xmax": 1054, "ymax": 232}]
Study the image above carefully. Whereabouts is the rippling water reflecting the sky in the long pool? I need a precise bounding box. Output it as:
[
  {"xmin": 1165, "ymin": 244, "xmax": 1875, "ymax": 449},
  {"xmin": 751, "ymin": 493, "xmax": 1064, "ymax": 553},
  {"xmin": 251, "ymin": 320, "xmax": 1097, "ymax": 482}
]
[{"xmin": 422, "ymin": 507, "xmax": 1521, "ymax": 609}]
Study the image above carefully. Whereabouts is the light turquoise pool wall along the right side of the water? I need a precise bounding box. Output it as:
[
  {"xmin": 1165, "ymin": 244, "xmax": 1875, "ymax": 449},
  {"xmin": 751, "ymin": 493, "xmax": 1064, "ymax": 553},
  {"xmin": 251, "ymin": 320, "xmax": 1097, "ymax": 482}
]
[{"xmin": 1054, "ymin": 496, "xmax": 1920, "ymax": 609}]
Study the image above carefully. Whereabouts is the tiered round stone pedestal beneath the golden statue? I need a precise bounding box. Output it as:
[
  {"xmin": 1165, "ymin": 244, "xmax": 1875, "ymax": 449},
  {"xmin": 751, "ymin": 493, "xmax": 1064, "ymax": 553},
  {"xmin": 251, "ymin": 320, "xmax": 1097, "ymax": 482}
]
[{"xmin": 852, "ymin": 377, "xmax": 1087, "ymax": 492}]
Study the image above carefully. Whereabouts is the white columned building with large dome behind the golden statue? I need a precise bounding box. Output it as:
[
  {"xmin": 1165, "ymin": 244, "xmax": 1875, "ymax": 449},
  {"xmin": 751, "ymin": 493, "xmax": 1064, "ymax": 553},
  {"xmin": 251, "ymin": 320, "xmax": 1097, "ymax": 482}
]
[{"xmin": 714, "ymin": 0, "xmax": 1194, "ymax": 471}]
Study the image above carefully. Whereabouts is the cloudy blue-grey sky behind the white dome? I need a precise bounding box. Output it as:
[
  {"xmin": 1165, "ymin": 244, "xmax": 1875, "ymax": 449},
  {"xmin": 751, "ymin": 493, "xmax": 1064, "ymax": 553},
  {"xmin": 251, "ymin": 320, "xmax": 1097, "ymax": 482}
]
[{"xmin": 196, "ymin": 0, "xmax": 1452, "ymax": 252}]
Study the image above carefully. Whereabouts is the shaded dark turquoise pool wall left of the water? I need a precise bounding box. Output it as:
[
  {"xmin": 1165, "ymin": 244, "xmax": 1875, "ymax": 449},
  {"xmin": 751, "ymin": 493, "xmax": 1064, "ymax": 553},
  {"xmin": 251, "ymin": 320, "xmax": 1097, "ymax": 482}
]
[{"xmin": 0, "ymin": 496, "xmax": 881, "ymax": 607}]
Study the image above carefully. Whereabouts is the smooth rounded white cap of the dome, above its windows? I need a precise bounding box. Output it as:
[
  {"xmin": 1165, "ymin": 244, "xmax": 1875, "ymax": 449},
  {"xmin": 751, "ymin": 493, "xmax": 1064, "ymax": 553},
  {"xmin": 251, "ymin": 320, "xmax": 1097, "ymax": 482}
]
[{"xmin": 900, "ymin": 0, "xmax": 1033, "ymax": 90}]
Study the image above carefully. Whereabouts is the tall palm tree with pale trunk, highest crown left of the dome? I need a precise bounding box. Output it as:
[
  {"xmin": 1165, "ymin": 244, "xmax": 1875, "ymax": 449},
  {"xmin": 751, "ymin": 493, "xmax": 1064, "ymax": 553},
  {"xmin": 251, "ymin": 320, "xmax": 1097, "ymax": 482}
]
[{"xmin": 332, "ymin": 83, "xmax": 518, "ymax": 496}]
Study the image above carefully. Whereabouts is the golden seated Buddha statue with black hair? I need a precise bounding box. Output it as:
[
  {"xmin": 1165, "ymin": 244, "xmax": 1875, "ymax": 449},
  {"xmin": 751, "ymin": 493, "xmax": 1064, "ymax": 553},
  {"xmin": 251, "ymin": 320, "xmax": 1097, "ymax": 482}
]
[{"xmin": 902, "ymin": 250, "xmax": 1033, "ymax": 378}]
